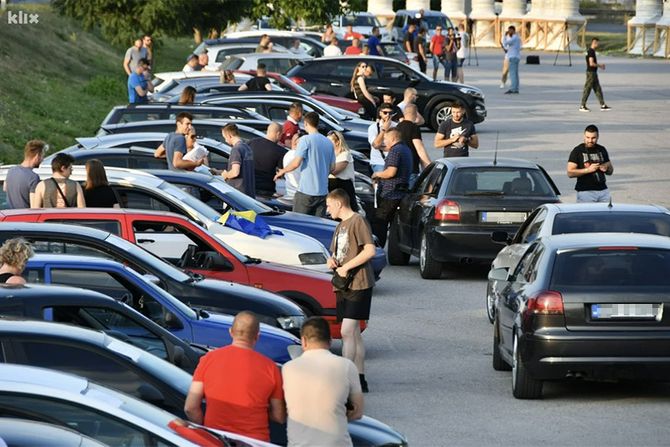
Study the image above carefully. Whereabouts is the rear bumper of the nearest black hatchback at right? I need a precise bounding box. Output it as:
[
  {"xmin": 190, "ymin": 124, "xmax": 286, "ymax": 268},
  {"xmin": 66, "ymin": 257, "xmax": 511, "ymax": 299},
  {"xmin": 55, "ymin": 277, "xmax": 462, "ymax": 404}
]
[{"xmin": 519, "ymin": 331, "xmax": 670, "ymax": 380}]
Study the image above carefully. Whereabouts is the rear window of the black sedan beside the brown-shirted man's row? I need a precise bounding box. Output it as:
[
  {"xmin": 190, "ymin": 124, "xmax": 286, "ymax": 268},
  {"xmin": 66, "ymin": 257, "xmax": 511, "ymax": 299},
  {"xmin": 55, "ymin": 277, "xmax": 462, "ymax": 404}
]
[{"xmin": 447, "ymin": 166, "xmax": 554, "ymax": 197}]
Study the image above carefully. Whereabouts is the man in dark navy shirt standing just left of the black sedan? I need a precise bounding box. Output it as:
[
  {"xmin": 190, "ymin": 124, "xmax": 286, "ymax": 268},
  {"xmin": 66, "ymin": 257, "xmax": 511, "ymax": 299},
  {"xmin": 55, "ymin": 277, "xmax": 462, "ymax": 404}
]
[{"xmin": 371, "ymin": 128, "xmax": 413, "ymax": 247}]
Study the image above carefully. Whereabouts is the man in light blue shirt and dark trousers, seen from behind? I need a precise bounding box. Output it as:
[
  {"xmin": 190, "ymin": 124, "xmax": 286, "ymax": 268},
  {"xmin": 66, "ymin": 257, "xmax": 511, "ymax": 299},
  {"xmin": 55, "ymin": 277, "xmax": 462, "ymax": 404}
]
[{"xmin": 274, "ymin": 112, "xmax": 335, "ymax": 217}]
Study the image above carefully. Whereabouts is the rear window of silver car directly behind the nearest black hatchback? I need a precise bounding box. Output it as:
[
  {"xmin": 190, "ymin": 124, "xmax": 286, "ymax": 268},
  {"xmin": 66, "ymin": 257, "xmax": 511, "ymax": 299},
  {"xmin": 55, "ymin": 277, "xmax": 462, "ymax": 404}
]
[{"xmin": 551, "ymin": 211, "xmax": 670, "ymax": 236}]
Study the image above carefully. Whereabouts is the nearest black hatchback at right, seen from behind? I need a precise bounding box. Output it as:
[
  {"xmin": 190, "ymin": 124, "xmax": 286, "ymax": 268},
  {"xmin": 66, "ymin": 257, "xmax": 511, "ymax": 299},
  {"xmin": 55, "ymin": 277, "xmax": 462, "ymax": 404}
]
[{"xmin": 491, "ymin": 233, "xmax": 670, "ymax": 399}]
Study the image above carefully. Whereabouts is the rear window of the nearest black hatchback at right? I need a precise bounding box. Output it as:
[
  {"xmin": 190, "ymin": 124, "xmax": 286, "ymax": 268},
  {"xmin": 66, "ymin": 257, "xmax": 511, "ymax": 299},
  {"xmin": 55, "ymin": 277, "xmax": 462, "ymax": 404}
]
[{"xmin": 551, "ymin": 247, "xmax": 670, "ymax": 287}]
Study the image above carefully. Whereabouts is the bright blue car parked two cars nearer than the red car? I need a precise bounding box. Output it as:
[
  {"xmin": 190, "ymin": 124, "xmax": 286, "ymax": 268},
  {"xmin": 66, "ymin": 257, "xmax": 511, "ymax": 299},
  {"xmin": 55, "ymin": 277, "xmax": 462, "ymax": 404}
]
[{"xmin": 26, "ymin": 255, "xmax": 300, "ymax": 363}]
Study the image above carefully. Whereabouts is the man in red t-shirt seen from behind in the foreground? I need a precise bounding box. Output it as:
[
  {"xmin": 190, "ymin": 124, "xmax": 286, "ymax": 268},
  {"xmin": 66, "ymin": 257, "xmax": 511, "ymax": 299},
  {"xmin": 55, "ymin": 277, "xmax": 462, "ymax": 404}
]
[{"xmin": 184, "ymin": 311, "xmax": 286, "ymax": 442}]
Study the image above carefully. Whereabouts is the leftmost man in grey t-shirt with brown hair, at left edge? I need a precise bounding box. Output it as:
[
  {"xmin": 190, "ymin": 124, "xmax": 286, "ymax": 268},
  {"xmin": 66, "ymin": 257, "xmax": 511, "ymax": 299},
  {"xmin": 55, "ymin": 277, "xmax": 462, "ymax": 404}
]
[{"xmin": 3, "ymin": 140, "xmax": 46, "ymax": 209}]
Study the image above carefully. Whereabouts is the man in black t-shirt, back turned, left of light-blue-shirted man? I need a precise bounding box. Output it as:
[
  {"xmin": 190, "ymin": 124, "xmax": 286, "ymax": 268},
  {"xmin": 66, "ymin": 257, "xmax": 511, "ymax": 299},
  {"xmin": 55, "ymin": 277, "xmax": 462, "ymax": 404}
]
[{"xmin": 249, "ymin": 123, "xmax": 286, "ymax": 197}]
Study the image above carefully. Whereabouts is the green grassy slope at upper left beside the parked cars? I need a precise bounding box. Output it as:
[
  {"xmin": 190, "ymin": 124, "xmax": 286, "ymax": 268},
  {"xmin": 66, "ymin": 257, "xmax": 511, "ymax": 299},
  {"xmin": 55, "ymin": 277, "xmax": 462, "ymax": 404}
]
[{"xmin": 0, "ymin": 4, "xmax": 195, "ymax": 163}]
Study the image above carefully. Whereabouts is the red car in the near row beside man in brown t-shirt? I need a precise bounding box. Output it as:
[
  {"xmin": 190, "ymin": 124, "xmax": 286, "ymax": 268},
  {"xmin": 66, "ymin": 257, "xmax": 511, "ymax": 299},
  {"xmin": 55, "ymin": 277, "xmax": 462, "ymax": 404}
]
[{"xmin": 0, "ymin": 208, "xmax": 364, "ymax": 338}]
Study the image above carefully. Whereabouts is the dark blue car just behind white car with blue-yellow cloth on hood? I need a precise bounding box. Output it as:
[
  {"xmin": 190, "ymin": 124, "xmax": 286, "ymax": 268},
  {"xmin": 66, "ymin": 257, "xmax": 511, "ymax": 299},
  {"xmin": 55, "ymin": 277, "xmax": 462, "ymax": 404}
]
[{"xmin": 146, "ymin": 169, "xmax": 386, "ymax": 278}]
